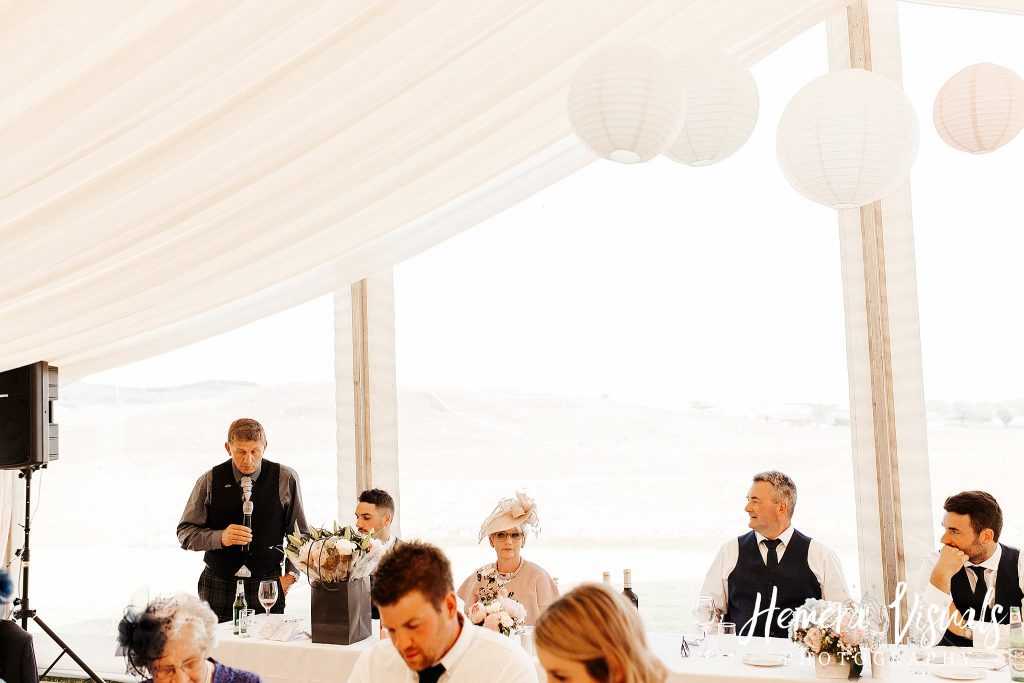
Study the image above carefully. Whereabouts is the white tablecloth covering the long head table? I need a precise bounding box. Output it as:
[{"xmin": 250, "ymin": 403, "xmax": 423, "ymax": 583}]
[{"xmin": 213, "ymin": 615, "xmax": 1009, "ymax": 683}]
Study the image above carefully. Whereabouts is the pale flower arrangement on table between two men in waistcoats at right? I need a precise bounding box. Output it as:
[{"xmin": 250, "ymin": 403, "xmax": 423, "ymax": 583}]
[{"xmin": 790, "ymin": 598, "xmax": 872, "ymax": 678}]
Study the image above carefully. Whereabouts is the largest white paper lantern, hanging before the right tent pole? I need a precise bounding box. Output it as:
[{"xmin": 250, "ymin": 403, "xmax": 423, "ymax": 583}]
[{"xmin": 776, "ymin": 69, "xmax": 919, "ymax": 209}]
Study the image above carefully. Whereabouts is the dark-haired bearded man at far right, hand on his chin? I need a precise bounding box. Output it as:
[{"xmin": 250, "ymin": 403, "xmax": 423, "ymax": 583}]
[{"xmin": 916, "ymin": 490, "xmax": 1024, "ymax": 648}]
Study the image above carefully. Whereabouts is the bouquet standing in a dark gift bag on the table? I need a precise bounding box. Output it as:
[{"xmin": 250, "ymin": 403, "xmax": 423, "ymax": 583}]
[{"xmin": 285, "ymin": 522, "xmax": 384, "ymax": 645}]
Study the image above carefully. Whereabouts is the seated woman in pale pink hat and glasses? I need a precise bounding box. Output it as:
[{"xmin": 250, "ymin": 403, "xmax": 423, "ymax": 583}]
[{"xmin": 459, "ymin": 492, "xmax": 558, "ymax": 626}]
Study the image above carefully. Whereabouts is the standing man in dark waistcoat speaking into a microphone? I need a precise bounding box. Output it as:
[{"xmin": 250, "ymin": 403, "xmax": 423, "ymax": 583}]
[{"xmin": 178, "ymin": 418, "xmax": 307, "ymax": 622}]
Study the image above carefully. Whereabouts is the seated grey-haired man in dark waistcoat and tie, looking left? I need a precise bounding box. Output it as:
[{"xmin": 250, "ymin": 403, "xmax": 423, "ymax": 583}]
[{"xmin": 700, "ymin": 470, "xmax": 849, "ymax": 638}]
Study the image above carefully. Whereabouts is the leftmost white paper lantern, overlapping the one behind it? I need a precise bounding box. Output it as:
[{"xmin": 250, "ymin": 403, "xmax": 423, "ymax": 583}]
[{"xmin": 568, "ymin": 45, "xmax": 685, "ymax": 164}]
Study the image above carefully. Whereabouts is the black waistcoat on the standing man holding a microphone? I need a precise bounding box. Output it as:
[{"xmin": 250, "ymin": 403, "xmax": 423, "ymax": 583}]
[{"xmin": 203, "ymin": 460, "xmax": 288, "ymax": 579}]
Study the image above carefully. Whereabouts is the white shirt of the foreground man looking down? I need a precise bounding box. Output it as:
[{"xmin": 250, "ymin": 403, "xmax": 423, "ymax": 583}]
[{"xmin": 348, "ymin": 613, "xmax": 538, "ymax": 683}]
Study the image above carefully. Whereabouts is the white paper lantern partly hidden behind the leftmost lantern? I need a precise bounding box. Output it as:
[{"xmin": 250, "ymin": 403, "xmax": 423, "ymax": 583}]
[{"xmin": 665, "ymin": 51, "xmax": 758, "ymax": 166}]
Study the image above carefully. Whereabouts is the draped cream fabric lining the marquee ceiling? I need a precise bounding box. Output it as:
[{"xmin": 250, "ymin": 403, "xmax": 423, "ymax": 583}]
[{"xmin": 0, "ymin": 0, "xmax": 847, "ymax": 383}]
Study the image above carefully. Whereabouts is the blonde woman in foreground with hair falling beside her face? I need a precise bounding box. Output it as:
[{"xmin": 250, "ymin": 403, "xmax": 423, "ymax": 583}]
[{"xmin": 534, "ymin": 584, "xmax": 669, "ymax": 683}]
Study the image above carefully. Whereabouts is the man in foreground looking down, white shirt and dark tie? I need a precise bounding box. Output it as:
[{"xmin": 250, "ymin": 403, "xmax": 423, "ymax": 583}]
[{"xmin": 348, "ymin": 543, "xmax": 538, "ymax": 683}]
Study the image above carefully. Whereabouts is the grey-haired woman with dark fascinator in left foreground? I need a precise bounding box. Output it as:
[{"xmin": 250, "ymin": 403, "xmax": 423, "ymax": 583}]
[{"xmin": 118, "ymin": 594, "xmax": 260, "ymax": 683}]
